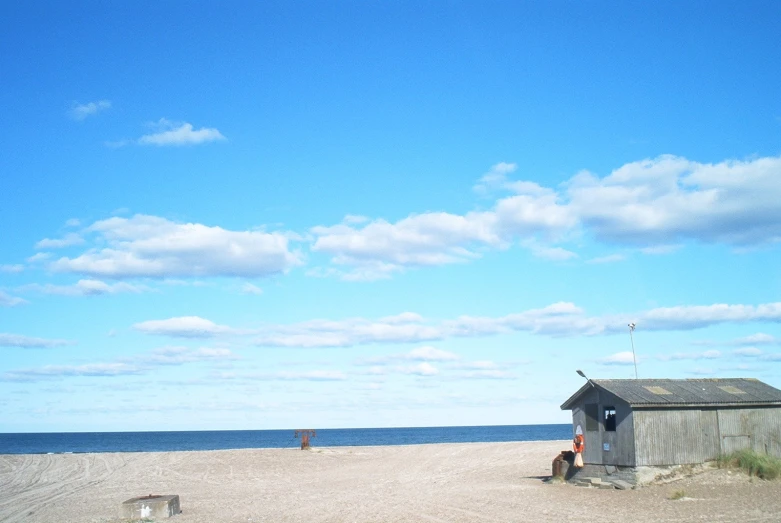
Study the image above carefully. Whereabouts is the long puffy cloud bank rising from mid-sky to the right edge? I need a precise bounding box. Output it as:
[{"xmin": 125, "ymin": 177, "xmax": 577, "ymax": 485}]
[{"xmin": 311, "ymin": 155, "xmax": 781, "ymax": 280}]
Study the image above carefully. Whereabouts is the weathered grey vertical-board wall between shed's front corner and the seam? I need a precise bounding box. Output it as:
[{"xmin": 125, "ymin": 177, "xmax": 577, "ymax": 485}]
[{"xmin": 634, "ymin": 409, "xmax": 716, "ymax": 466}]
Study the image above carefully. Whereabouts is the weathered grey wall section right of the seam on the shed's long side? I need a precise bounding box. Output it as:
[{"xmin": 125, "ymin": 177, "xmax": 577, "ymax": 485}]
[{"xmin": 718, "ymin": 408, "xmax": 781, "ymax": 457}]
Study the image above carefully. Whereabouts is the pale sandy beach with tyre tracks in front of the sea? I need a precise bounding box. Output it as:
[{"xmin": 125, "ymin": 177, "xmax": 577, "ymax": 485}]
[{"xmin": 0, "ymin": 441, "xmax": 781, "ymax": 523}]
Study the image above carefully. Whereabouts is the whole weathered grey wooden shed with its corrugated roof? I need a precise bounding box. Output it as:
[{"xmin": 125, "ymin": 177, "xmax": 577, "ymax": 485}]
[{"xmin": 561, "ymin": 379, "xmax": 781, "ymax": 469}]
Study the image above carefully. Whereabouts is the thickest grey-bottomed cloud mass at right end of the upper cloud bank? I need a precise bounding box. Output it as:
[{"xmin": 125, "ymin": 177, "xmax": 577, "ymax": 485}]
[{"xmin": 567, "ymin": 155, "xmax": 781, "ymax": 246}]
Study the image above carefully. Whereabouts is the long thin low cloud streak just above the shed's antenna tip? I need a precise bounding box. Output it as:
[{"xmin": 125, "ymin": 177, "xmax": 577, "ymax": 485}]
[{"xmin": 135, "ymin": 302, "xmax": 781, "ymax": 348}]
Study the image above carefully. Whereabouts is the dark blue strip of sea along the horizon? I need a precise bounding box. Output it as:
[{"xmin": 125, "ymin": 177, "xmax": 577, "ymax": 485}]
[{"xmin": 0, "ymin": 424, "xmax": 572, "ymax": 454}]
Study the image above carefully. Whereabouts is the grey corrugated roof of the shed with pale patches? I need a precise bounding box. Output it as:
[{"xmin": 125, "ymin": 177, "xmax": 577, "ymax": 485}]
[{"xmin": 561, "ymin": 378, "xmax": 781, "ymax": 410}]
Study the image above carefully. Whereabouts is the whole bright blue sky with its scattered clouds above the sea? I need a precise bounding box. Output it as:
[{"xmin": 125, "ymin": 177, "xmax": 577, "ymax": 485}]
[{"xmin": 0, "ymin": 1, "xmax": 781, "ymax": 432}]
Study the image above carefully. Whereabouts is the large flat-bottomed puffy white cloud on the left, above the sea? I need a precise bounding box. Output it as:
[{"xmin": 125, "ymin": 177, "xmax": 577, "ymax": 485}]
[{"xmin": 50, "ymin": 215, "xmax": 301, "ymax": 278}]
